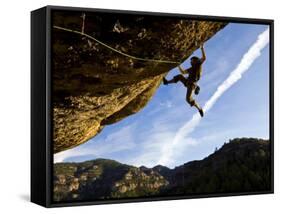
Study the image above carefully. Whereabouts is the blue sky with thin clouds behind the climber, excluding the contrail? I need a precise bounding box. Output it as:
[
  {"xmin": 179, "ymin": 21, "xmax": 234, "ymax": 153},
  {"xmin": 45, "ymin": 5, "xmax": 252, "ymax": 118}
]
[{"xmin": 55, "ymin": 24, "xmax": 269, "ymax": 168}]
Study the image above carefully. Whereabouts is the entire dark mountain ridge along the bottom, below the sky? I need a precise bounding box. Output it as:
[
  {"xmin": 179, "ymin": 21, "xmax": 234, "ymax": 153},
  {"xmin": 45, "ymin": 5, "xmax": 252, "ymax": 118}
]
[{"xmin": 53, "ymin": 138, "xmax": 271, "ymax": 202}]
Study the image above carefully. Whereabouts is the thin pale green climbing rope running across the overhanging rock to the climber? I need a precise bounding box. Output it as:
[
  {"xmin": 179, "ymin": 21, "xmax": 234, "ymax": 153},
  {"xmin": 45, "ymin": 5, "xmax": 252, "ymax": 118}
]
[{"xmin": 53, "ymin": 26, "xmax": 181, "ymax": 65}]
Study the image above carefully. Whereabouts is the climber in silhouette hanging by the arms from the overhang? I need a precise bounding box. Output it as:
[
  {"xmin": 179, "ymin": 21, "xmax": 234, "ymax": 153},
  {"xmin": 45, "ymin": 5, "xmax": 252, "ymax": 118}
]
[{"xmin": 163, "ymin": 45, "xmax": 206, "ymax": 117}]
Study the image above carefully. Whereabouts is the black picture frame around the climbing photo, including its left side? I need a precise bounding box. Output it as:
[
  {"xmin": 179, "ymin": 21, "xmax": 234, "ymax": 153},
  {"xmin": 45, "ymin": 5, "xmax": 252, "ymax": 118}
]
[{"xmin": 31, "ymin": 6, "xmax": 274, "ymax": 207}]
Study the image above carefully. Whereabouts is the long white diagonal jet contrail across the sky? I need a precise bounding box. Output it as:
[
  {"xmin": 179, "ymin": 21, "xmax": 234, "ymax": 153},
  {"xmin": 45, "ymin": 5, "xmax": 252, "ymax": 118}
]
[{"xmin": 158, "ymin": 29, "xmax": 269, "ymax": 165}]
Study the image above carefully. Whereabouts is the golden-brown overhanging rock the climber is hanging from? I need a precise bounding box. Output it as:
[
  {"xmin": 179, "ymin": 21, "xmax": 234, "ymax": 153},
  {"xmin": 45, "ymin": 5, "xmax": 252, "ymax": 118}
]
[{"xmin": 52, "ymin": 11, "xmax": 226, "ymax": 153}]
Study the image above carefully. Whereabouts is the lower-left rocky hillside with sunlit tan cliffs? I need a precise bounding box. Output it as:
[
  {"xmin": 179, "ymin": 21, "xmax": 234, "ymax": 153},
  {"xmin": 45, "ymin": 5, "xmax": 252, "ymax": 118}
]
[{"xmin": 53, "ymin": 159, "xmax": 169, "ymax": 201}]
